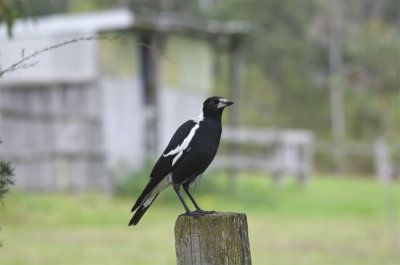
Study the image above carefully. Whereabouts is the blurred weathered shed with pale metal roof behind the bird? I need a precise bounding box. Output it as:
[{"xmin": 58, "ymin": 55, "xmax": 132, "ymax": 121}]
[{"xmin": 0, "ymin": 9, "xmax": 250, "ymax": 192}]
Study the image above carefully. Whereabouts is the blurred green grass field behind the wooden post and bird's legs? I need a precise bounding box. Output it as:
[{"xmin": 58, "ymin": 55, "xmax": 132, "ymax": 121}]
[{"xmin": 0, "ymin": 174, "xmax": 400, "ymax": 265}]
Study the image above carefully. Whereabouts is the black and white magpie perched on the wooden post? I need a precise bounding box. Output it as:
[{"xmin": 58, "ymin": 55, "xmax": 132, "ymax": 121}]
[{"xmin": 129, "ymin": 97, "xmax": 233, "ymax": 225}]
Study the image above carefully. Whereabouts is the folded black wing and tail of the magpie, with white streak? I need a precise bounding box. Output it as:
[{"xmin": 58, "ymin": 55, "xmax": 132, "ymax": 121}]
[{"xmin": 132, "ymin": 120, "xmax": 199, "ymax": 216}]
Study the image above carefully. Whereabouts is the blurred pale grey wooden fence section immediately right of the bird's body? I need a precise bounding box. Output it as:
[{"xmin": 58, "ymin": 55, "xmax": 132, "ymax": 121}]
[{"xmin": 214, "ymin": 127, "xmax": 313, "ymax": 185}]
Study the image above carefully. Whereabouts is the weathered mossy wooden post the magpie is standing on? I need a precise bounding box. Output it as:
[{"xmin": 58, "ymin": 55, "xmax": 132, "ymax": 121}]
[{"xmin": 175, "ymin": 210, "xmax": 251, "ymax": 265}]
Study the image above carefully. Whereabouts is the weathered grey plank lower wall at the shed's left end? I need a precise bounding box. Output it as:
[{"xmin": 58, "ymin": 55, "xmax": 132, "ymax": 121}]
[{"xmin": 0, "ymin": 83, "xmax": 110, "ymax": 192}]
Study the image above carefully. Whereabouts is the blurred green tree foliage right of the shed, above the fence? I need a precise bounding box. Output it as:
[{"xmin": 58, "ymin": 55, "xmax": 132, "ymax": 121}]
[{"xmin": 209, "ymin": 0, "xmax": 400, "ymax": 140}]
